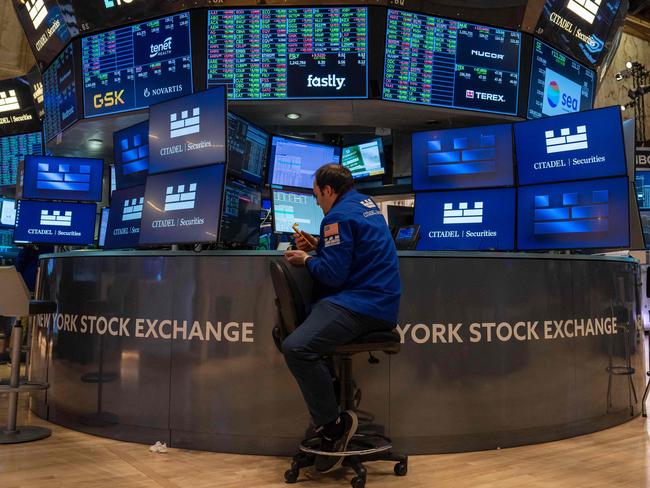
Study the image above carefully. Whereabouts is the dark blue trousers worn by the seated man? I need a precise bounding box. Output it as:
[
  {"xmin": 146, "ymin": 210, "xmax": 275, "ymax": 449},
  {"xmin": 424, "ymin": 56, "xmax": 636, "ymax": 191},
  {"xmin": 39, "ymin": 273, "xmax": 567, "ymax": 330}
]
[{"xmin": 282, "ymin": 300, "xmax": 395, "ymax": 426}]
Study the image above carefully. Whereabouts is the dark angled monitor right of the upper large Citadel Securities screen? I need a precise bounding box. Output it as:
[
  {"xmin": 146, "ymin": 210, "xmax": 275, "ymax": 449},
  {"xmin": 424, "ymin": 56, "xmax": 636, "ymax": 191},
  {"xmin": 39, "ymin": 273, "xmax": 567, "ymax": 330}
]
[{"xmin": 228, "ymin": 112, "xmax": 270, "ymax": 183}]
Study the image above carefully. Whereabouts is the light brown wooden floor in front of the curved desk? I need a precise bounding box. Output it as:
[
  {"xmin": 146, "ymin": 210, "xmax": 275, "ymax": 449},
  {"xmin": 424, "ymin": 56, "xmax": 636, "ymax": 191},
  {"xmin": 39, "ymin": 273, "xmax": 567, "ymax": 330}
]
[{"xmin": 0, "ymin": 367, "xmax": 650, "ymax": 488}]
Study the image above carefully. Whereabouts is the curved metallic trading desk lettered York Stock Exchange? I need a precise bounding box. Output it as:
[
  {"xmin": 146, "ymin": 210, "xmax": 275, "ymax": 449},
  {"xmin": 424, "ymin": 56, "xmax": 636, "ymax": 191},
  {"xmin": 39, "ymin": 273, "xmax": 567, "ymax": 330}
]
[{"xmin": 31, "ymin": 252, "xmax": 645, "ymax": 455}]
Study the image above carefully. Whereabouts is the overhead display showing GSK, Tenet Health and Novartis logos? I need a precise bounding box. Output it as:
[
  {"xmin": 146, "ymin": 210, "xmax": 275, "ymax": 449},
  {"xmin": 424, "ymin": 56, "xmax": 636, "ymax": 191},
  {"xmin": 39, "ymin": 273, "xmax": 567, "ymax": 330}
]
[{"xmin": 82, "ymin": 13, "xmax": 192, "ymax": 117}]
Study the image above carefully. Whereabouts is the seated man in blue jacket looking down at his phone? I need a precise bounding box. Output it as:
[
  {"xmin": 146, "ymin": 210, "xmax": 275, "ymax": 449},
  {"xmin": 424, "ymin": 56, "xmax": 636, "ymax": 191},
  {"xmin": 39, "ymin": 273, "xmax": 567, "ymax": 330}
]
[{"xmin": 282, "ymin": 164, "xmax": 401, "ymax": 472}]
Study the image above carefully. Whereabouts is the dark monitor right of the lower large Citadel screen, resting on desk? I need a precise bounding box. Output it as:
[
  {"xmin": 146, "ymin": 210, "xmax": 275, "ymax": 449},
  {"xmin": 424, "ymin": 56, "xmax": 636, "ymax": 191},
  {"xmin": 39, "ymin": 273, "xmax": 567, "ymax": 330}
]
[{"xmin": 220, "ymin": 181, "xmax": 262, "ymax": 246}]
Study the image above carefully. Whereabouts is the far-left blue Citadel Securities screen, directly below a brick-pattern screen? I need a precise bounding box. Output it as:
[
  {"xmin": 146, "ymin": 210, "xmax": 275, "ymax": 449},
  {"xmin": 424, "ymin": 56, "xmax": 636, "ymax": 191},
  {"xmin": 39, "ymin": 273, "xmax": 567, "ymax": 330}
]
[{"xmin": 14, "ymin": 200, "xmax": 97, "ymax": 246}]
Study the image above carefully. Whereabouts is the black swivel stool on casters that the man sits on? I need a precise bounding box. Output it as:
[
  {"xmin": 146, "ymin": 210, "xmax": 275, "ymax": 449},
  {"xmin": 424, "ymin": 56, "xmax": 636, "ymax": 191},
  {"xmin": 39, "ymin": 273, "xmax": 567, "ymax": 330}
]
[{"xmin": 271, "ymin": 261, "xmax": 408, "ymax": 488}]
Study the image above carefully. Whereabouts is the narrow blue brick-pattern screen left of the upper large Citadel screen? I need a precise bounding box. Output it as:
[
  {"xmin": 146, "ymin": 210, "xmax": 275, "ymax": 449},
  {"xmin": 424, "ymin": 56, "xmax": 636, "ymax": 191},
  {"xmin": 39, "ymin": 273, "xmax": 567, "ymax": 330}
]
[{"xmin": 113, "ymin": 120, "xmax": 149, "ymax": 189}]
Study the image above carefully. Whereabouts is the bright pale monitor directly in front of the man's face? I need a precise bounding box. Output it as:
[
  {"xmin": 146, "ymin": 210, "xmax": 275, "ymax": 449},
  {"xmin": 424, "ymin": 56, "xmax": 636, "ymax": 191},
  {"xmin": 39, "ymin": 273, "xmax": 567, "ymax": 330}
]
[{"xmin": 272, "ymin": 189, "xmax": 323, "ymax": 236}]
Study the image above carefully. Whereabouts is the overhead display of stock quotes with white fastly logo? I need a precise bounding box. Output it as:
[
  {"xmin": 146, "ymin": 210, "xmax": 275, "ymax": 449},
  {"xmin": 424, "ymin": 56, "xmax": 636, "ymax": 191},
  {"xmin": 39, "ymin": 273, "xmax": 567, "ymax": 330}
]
[{"xmin": 208, "ymin": 7, "xmax": 368, "ymax": 100}]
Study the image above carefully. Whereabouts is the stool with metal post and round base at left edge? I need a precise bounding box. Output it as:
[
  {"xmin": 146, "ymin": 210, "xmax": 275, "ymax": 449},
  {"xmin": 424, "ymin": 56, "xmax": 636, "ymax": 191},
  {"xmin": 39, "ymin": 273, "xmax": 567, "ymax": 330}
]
[{"xmin": 0, "ymin": 266, "xmax": 56, "ymax": 444}]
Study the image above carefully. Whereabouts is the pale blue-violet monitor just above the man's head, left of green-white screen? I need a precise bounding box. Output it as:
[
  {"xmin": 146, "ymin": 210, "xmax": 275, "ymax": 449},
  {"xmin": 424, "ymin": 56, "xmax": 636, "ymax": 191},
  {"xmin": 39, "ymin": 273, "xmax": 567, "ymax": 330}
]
[{"xmin": 269, "ymin": 136, "xmax": 341, "ymax": 189}]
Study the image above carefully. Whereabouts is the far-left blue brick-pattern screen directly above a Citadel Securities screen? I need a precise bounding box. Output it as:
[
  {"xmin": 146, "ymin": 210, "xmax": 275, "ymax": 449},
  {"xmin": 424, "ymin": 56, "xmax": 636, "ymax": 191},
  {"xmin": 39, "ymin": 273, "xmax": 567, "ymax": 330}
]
[{"xmin": 23, "ymin": 156, "xmax": 104, "ymax": 202}]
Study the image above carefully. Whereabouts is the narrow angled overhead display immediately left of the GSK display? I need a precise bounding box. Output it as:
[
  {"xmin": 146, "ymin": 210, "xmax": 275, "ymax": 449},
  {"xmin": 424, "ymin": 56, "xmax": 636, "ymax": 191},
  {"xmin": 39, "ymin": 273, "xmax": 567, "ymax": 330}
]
[{"xmin": 43, "ymin": 44, "xmax": 82, "ymax": 141}]
